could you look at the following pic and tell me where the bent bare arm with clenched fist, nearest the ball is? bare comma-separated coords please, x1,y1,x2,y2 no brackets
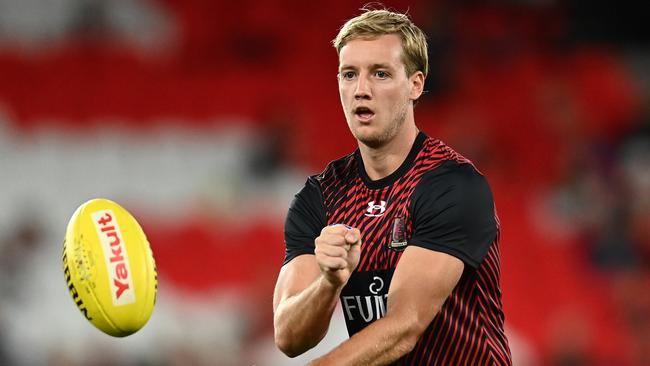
273,225,361,357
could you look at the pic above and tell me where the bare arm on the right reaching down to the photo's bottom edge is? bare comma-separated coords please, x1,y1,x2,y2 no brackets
310,246,464,365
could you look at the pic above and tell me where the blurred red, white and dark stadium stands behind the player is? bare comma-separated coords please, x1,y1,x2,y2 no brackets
0,0,650,365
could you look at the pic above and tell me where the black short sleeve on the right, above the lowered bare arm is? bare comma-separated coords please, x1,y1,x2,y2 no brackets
409,161,497,268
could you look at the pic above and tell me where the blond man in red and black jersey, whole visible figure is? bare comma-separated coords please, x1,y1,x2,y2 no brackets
273,10,511,365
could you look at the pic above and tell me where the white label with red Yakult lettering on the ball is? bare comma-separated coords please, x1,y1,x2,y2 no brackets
91,210,135,305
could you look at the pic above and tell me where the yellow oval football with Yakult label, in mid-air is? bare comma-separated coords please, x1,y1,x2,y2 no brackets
63,198,158,337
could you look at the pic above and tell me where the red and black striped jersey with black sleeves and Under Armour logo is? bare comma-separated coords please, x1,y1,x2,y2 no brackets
284,132,512,365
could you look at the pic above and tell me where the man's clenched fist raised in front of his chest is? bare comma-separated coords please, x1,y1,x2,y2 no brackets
315,225,361,288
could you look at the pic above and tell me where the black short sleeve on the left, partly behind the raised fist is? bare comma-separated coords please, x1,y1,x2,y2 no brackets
283,177,327,265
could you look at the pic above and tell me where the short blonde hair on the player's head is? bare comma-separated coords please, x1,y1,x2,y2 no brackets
332,8,429,78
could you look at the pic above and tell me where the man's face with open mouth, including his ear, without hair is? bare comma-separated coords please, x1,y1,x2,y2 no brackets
338,34,421,148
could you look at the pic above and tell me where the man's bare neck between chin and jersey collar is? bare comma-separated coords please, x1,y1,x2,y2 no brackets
359,124,418,180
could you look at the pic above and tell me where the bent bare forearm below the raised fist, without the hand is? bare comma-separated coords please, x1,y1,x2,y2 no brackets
274,277,341,357
